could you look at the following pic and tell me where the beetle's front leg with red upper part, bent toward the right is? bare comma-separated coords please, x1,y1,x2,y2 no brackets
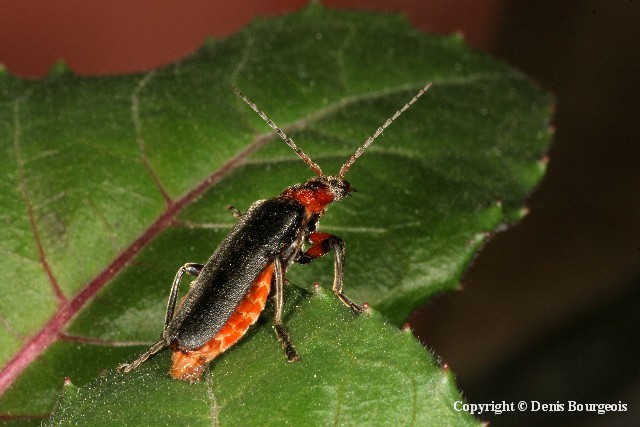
298,232,363,313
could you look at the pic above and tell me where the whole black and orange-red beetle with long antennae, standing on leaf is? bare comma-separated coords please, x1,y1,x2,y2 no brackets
118,83,431,382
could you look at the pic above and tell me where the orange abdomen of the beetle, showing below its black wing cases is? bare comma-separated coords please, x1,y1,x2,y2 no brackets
170,264,274,381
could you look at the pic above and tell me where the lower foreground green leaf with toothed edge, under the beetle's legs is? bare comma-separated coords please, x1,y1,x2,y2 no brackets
49,288,478,426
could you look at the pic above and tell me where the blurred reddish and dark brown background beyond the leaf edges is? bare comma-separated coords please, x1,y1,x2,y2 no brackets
0,0,640,426
